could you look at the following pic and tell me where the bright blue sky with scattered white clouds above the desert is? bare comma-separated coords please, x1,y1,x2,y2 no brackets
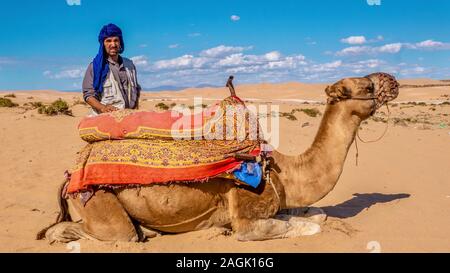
0,0,450,90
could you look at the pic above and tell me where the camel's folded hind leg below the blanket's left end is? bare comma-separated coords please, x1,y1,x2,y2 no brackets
46,190,139,242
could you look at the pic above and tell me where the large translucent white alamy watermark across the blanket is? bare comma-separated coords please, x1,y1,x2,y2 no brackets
171,97,280,149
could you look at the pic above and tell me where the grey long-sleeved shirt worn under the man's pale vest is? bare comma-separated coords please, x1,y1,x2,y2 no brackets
83,56,141,109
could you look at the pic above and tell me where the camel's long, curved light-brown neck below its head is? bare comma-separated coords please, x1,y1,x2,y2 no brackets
274,102,361,207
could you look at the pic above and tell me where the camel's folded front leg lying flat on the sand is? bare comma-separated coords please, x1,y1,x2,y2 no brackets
233,217,320,241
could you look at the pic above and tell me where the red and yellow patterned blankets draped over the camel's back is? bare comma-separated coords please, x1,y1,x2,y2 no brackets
68,97,261,193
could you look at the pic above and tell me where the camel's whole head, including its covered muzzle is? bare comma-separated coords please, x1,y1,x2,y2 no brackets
325,73,399,119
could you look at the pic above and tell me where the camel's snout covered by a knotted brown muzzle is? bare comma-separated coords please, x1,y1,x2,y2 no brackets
365,72,400,109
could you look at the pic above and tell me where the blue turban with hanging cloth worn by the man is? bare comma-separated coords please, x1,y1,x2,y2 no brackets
92,24,125,95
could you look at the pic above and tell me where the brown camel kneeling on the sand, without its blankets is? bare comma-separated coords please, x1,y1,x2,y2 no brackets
38,73,399,243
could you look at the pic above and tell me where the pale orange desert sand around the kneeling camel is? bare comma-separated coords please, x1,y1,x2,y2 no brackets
0,79,450,252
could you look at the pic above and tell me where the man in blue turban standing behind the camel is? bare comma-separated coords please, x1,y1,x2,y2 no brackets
83,24,141,115
